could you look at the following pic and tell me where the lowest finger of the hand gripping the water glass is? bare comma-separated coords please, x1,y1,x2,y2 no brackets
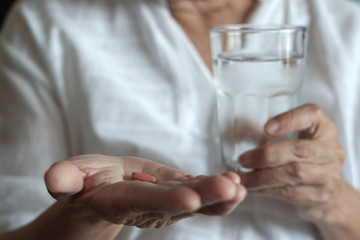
257,185,331,206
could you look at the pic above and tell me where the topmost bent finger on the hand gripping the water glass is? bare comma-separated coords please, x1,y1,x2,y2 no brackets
265,104,336,139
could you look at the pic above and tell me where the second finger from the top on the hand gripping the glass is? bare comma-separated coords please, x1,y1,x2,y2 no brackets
239,139,335,169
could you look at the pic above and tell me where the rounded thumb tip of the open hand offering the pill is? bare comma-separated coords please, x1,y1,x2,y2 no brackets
44,161,84,202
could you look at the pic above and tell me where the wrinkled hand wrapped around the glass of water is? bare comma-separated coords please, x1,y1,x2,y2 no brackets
239,104,345,221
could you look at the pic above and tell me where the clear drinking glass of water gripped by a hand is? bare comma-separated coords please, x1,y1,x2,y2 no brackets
210,24,306,172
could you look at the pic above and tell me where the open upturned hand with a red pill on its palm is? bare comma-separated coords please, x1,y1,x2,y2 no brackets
45,155,246,228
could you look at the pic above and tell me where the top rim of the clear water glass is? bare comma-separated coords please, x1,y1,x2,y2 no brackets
210,24,307,33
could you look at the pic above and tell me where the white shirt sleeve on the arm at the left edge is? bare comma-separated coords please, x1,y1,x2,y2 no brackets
0,1,68,232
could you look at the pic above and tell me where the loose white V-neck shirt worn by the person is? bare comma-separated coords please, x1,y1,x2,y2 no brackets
0,0,360,240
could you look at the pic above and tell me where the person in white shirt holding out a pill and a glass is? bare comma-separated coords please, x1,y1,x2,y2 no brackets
0,0,360,240
